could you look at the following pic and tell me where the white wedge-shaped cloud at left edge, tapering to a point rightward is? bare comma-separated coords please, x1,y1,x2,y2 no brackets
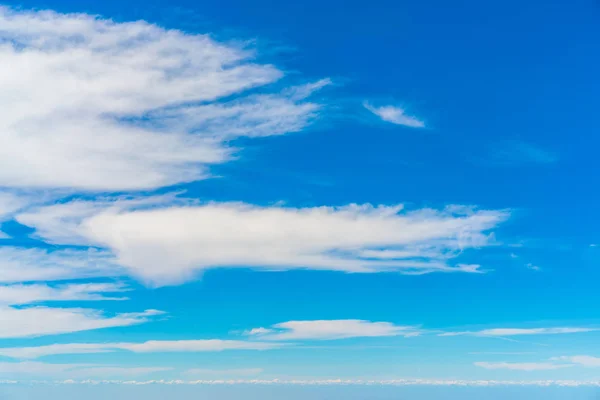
0,306,162,339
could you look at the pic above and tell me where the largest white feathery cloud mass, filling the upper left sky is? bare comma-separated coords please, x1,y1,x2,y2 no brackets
0,7,327,190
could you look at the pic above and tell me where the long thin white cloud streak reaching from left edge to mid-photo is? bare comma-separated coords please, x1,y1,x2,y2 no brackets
0,339,284,359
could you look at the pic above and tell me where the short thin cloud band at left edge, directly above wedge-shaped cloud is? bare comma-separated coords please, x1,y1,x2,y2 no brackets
0,283,127,305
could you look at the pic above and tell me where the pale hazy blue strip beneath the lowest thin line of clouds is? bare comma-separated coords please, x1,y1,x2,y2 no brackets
0,385,600,400
